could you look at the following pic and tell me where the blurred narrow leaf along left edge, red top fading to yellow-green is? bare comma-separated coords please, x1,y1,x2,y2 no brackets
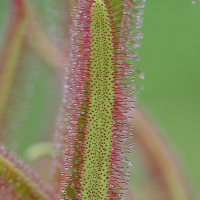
0,0,26,136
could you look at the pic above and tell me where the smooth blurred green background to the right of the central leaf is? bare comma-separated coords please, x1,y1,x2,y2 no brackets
139,0,200,192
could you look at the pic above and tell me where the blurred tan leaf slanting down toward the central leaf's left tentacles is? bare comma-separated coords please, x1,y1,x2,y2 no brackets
25,2,70,74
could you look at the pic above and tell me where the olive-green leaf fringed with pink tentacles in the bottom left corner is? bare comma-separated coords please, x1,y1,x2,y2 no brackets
0,145,57,200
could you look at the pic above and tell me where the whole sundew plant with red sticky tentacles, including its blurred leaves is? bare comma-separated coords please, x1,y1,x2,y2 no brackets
0,0,195,200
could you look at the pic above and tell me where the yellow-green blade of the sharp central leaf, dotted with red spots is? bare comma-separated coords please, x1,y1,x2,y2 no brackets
81,0,114,199
